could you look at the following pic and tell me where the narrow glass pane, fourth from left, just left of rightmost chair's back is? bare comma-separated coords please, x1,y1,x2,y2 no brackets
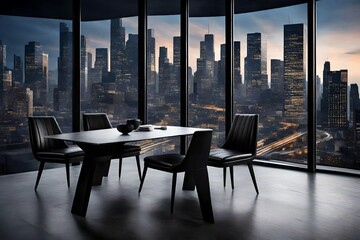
188,1,225,147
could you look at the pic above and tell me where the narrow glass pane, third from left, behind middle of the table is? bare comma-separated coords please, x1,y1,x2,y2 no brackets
147,0,180,153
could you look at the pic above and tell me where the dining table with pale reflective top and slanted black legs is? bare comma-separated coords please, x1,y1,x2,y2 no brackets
46,126,214,223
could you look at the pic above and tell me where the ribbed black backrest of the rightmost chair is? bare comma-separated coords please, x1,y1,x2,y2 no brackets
223,114,259,155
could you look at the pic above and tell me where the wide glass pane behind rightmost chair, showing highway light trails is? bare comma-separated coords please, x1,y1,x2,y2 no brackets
234,4,307,163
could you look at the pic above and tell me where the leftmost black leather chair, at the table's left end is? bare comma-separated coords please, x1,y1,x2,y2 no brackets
29,116,84,190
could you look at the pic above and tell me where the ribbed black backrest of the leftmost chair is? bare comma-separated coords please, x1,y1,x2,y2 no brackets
29,116,68,154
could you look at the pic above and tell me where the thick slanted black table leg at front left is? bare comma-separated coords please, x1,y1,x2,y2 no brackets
71,154,96,217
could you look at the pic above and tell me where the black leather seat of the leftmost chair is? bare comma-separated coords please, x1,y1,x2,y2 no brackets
36,146,84,162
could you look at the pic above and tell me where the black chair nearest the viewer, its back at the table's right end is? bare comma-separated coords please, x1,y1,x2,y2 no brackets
139,130,212,213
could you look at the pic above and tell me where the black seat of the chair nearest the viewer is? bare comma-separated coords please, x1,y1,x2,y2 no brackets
144,154,185,170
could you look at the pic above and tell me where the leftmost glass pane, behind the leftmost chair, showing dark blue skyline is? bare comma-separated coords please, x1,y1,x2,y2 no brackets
0,16,73,174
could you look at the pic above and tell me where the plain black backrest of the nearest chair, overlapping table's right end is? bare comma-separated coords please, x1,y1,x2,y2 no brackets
181,130,212,170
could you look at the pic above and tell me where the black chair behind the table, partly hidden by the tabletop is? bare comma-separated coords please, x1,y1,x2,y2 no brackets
83,113,141,179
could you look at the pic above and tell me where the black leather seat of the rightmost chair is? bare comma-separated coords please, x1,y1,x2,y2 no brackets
208,148,253,165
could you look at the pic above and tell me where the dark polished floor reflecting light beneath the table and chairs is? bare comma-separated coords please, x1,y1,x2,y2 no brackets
0,159,360,240
